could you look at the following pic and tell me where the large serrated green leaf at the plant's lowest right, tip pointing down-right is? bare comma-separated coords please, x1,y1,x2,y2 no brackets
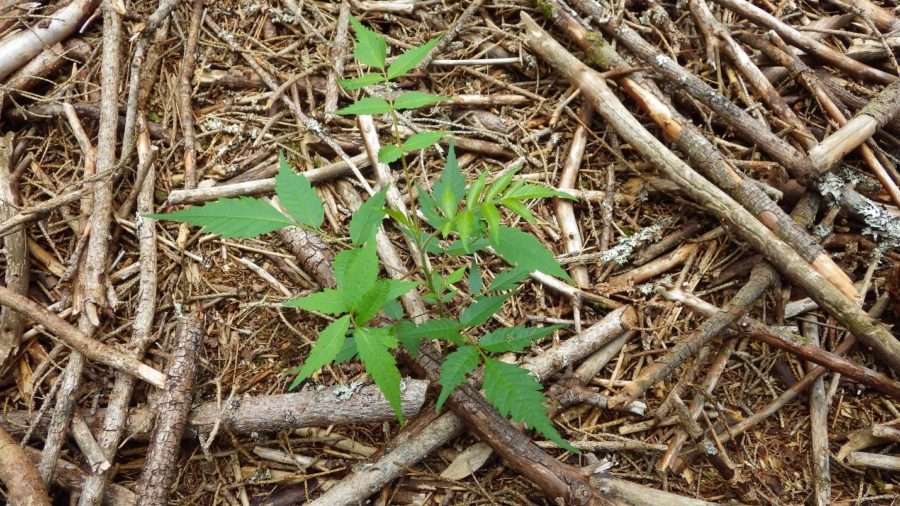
483,358,581,454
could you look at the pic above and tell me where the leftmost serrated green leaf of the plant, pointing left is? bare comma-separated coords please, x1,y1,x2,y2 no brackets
147,197,294,237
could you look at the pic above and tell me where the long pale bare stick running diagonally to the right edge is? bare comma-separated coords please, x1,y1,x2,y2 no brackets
523,15,900,371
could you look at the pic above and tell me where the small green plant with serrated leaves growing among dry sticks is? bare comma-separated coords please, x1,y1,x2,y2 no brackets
152,18,577,451
